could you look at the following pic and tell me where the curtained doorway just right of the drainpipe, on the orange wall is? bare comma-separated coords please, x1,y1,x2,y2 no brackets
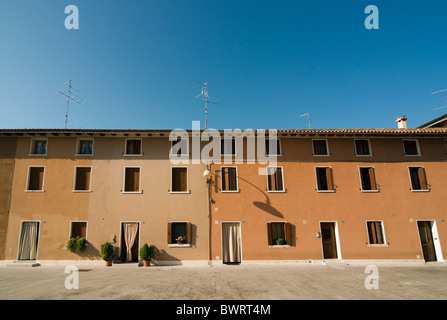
222,222,241,264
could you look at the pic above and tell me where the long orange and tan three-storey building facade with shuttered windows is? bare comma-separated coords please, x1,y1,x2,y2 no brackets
0,128,447,264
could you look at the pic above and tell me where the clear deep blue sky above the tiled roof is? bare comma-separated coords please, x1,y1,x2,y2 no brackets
0,0,447,129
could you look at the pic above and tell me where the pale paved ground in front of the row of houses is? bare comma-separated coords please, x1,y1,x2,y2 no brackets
0,263,447,300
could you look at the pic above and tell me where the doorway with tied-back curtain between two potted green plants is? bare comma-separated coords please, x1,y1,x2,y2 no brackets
120,222,140,262
